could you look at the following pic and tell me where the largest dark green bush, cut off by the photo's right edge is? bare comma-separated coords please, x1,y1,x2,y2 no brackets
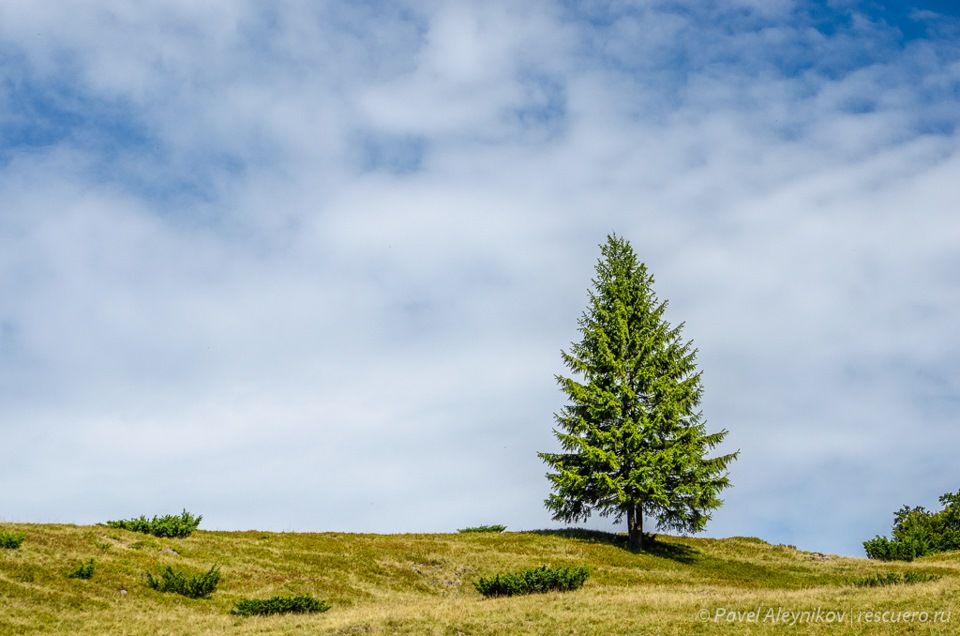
863,491,960,561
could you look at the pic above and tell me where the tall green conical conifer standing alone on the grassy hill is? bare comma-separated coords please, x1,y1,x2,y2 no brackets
539,234,739,548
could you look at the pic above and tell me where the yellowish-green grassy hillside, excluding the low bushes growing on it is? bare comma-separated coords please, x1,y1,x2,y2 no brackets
0,523,960,636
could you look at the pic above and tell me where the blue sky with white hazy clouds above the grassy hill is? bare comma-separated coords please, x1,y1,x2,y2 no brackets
0,0,960,556
